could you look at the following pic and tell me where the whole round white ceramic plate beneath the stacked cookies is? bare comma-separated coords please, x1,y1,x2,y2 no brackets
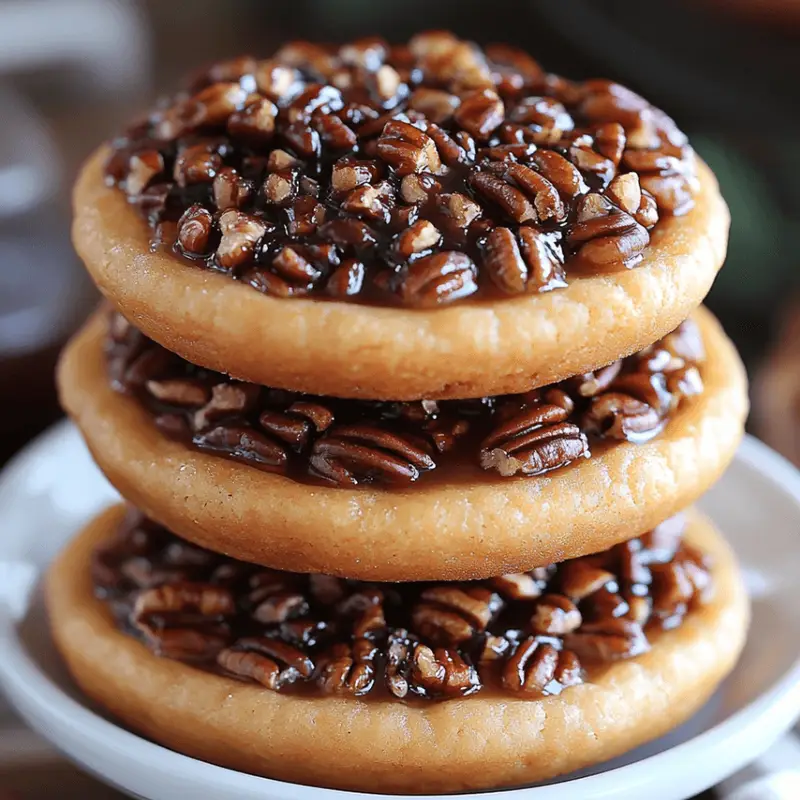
0,424,800,800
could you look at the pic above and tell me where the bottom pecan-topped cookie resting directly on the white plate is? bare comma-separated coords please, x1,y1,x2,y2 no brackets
47,507,748,793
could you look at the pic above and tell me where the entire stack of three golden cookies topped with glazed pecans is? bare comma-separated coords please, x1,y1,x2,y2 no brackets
48,32,748,792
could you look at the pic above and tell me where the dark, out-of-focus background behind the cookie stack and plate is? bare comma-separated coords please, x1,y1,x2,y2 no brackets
0,0,800,797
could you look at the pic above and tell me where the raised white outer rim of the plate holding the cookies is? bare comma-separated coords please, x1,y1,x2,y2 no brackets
0,420,800,800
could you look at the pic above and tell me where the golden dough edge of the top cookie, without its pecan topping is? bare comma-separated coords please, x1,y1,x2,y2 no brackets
73,149,729,400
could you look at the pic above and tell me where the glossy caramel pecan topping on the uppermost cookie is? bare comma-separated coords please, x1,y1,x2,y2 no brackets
106,32,695,307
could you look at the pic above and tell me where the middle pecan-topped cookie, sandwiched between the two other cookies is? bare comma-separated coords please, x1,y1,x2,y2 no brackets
59,310,747,581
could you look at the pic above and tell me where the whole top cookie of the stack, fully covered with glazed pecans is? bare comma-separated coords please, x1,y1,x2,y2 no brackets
75,33,727,399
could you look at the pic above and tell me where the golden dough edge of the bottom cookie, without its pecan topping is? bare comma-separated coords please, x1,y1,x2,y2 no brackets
47,507,749,793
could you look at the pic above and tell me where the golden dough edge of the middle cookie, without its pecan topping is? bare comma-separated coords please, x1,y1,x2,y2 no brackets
58,309,747,580
